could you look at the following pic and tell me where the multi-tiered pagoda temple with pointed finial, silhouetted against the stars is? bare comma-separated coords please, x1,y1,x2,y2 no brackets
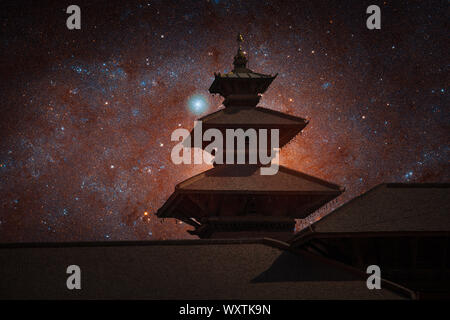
157,35,344,240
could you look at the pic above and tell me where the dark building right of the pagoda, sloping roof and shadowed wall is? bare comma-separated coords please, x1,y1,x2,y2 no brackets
291,183,450,298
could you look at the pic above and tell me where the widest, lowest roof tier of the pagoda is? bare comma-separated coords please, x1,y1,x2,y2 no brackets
157,165,343,222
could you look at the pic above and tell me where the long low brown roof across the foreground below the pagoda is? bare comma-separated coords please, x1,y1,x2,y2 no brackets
0,239,411,299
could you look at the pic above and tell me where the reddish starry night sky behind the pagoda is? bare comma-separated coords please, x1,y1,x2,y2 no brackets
0,0,450,242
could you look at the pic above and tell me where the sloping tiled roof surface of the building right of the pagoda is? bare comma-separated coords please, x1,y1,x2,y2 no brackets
296,183,450,233
